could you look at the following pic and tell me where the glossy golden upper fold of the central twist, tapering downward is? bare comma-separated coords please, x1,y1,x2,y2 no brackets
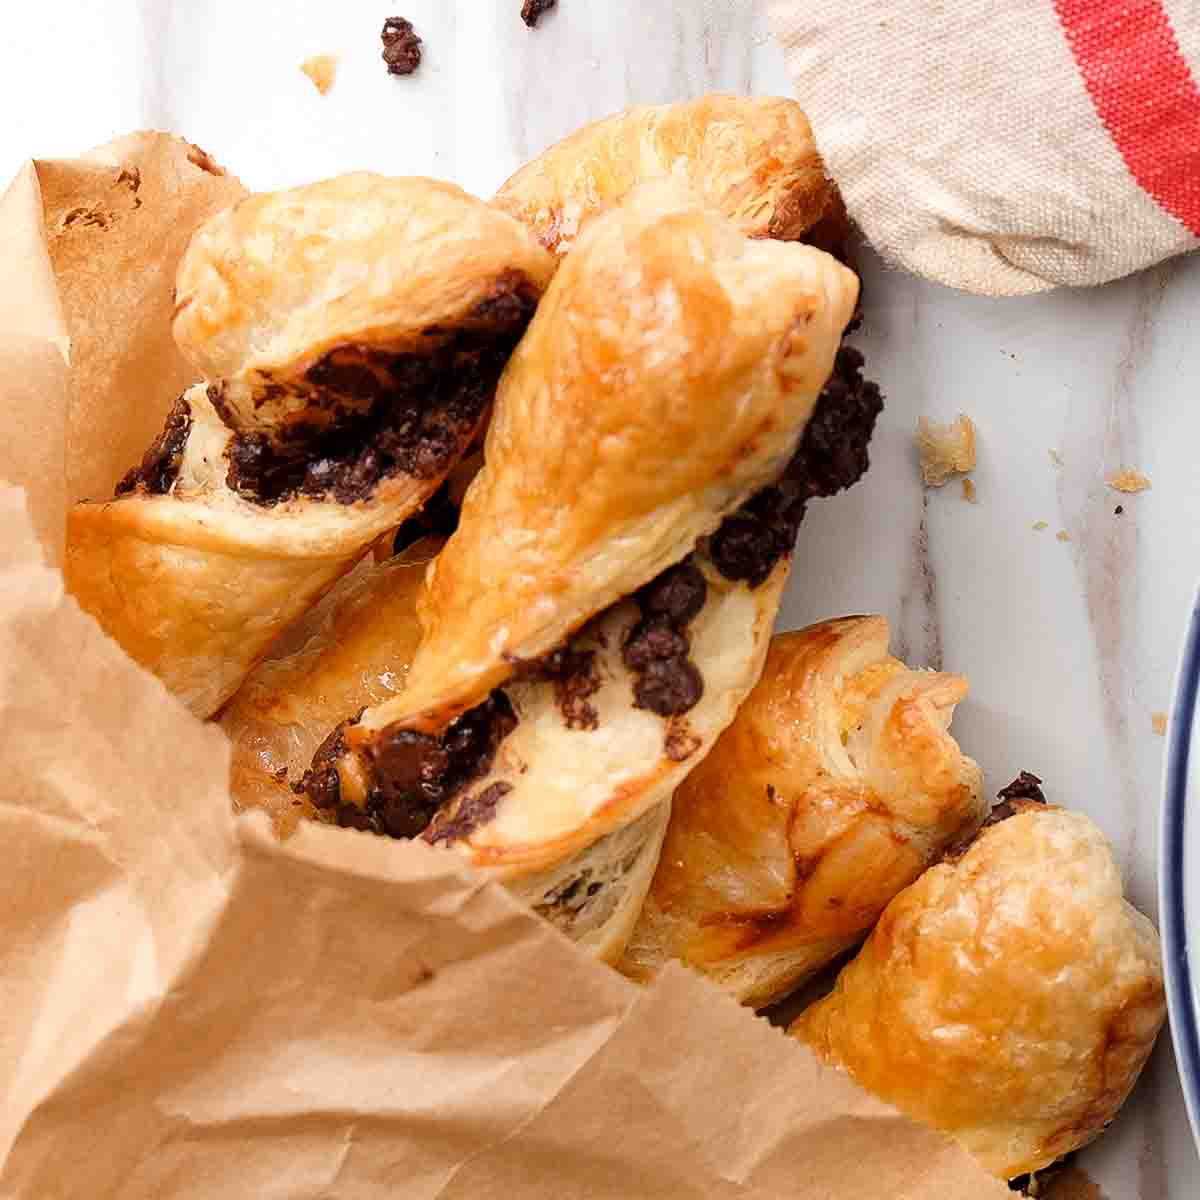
348,182,859,745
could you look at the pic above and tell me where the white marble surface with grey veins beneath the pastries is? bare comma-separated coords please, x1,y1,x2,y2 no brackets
0,0,1200,1200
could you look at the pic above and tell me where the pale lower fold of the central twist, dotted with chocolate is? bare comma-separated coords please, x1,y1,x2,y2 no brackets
304,553,788,962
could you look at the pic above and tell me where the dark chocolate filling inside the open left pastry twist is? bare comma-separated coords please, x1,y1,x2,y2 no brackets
222,272,538,504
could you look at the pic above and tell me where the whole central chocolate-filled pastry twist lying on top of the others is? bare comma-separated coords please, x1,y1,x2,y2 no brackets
292,182,880,954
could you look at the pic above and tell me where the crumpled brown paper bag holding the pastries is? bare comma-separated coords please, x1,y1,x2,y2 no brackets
0,134,1009,1200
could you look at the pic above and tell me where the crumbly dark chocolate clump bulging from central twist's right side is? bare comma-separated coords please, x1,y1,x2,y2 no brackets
708,346,883,588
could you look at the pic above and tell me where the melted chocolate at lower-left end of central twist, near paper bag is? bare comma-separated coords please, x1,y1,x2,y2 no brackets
298,691,517,840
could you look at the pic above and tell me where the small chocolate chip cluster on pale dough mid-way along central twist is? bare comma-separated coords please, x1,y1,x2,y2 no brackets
622,559,708,716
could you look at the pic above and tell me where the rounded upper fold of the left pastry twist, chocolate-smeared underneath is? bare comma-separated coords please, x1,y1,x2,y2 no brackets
174,172,553,442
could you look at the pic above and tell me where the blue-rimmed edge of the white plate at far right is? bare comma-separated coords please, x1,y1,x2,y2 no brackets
1158,594,1200,1145
